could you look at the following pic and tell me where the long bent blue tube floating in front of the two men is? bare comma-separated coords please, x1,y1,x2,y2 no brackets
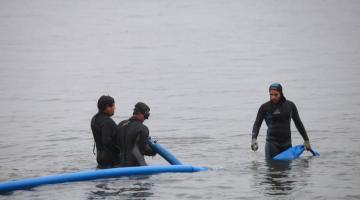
0,140,208,193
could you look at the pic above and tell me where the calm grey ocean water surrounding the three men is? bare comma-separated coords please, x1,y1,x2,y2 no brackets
0,0,360,199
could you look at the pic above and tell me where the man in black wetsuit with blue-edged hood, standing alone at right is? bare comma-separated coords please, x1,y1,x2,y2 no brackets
251,83,311,159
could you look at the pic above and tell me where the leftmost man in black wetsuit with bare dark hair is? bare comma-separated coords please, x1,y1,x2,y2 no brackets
91,96,120,169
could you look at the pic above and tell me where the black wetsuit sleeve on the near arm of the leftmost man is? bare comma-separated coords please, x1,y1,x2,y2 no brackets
101,121,120,153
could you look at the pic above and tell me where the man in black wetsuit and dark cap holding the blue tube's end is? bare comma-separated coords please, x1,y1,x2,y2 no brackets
117,102,156,167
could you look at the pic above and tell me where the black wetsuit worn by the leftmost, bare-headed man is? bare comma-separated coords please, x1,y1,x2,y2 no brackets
91,111,120,168
